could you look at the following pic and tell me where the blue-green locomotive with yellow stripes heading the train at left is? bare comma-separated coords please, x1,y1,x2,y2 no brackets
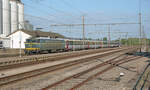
25,38,65,54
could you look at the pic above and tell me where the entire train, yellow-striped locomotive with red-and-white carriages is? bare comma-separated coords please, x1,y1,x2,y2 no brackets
25,37,119,54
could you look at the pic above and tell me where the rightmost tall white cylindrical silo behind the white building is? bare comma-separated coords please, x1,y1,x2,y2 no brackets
18,1,24,29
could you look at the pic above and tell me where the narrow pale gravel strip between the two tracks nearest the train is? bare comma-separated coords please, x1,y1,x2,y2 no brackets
0,50,122,78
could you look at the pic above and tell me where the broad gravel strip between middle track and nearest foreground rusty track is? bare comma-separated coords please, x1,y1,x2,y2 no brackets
2,50,124,90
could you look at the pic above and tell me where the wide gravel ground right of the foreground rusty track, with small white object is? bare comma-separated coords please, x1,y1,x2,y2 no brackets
78,57,149,90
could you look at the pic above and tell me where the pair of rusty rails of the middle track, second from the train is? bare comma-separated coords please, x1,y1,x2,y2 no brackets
0,49,131,86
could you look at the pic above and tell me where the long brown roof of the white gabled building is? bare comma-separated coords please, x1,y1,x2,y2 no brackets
7,30,65,38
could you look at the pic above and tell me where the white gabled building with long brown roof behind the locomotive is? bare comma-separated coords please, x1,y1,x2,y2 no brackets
7,30,65,49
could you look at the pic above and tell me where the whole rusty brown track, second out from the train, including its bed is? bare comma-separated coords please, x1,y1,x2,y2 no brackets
0,49,131,87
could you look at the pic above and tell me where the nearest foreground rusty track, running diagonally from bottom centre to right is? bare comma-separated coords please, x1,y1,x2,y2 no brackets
42,53,140,90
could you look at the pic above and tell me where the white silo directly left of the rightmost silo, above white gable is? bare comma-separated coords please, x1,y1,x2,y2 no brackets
10,0,19,33
